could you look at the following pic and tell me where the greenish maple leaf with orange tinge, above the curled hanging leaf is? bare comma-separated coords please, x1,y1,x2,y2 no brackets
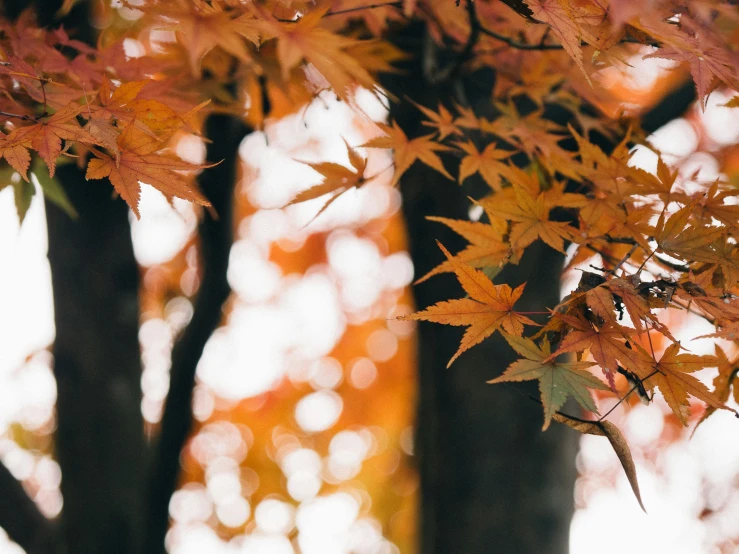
488,333,608,430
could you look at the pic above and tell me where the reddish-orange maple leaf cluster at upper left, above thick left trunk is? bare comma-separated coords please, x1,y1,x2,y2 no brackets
0,15,220,216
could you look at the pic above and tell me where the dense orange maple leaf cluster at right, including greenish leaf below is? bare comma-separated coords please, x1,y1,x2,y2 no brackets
398,112,739,428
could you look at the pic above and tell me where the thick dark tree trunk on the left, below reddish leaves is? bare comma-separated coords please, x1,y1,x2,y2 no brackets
47,165,145,554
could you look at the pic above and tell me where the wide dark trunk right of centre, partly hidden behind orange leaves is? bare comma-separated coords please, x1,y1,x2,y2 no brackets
382,26,577,554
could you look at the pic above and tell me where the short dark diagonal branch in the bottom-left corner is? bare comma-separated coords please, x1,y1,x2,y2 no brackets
0,463,58,554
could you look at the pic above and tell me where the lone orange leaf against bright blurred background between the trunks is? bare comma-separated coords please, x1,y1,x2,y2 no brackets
285,141,371,219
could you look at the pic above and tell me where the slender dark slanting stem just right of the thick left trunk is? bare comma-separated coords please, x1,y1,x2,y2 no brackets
144,115,250,554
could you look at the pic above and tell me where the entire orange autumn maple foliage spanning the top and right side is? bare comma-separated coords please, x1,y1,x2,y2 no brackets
0,0,739,508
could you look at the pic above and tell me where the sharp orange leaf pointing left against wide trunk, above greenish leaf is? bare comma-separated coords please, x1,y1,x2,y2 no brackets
399,241,536,367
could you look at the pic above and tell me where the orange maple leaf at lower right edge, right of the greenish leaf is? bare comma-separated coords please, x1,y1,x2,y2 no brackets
637,343,734,426
